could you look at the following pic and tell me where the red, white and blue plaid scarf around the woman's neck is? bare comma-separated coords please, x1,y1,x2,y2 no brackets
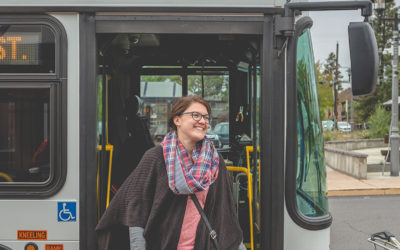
161,132,219,194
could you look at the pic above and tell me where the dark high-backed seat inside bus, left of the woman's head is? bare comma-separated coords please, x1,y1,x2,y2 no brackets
112,94,154,188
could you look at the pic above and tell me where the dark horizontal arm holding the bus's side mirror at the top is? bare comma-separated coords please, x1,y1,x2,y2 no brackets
285,1,372,21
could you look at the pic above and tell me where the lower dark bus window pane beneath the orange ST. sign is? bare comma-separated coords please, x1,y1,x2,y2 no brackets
0,88,51,183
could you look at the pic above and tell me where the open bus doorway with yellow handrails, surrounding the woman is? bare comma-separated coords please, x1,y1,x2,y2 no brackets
96,15,264,249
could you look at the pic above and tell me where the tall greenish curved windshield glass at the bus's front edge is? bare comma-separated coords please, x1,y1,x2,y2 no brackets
296,29,328,217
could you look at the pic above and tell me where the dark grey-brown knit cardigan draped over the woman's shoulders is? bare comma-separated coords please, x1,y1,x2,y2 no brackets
96,146,242,250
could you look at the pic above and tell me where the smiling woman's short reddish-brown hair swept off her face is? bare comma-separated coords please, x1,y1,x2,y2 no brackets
168,95,211,131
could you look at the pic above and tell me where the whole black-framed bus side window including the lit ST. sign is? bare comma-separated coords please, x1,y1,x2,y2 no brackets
0,15,68,198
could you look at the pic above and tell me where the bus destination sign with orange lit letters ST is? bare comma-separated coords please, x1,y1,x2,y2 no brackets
0,32,41,65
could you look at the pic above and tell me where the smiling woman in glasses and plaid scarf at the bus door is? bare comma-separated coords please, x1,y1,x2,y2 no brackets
96,96,245,250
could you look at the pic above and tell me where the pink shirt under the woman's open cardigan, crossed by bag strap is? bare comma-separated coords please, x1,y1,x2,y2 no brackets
178,190,208,250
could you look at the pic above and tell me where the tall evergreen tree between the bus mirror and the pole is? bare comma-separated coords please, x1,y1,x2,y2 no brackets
354,2,398,122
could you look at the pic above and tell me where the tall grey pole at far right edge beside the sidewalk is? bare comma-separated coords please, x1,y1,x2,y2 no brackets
390,13,400,176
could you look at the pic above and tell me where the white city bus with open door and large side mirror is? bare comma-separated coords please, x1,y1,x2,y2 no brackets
0,0,378,250
